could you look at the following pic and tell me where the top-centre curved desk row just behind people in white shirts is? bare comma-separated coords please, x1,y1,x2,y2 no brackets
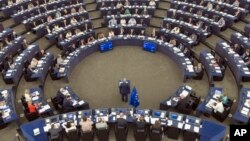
100,5,155,16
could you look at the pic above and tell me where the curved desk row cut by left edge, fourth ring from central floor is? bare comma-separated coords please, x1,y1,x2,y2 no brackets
0,36,24,64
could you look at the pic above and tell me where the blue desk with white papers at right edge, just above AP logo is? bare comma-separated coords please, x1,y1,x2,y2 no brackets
232,88,250,124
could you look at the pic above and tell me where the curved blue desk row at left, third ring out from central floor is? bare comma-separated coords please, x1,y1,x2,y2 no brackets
4,45,39,85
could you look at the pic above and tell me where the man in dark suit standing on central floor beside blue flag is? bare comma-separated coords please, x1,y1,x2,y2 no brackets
119,78,130,102
